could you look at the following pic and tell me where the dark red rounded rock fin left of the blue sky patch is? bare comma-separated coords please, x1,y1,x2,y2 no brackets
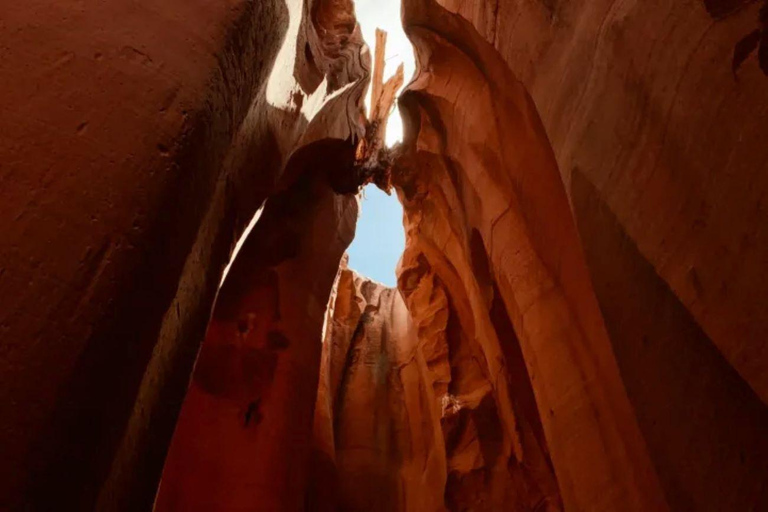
155,172,357,512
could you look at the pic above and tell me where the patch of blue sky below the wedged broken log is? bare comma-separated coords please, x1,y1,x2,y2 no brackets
347,185,405,286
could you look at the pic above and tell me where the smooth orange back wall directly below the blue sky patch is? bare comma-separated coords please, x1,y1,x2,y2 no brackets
309,268,446,512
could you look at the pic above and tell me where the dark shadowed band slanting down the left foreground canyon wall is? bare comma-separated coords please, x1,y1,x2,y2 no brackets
26,0,288,510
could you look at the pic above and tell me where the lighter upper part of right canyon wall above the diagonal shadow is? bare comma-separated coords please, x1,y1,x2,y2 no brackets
440,0,768,410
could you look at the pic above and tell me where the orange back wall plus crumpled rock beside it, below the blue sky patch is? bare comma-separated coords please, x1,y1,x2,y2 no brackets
308,260,562,512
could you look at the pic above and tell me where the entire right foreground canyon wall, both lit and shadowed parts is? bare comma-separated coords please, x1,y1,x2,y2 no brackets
428,0,768,510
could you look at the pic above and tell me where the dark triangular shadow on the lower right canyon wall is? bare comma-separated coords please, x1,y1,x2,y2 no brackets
571,168,768,511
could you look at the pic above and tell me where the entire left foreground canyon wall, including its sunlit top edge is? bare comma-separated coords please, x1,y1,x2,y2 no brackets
0,0,369,510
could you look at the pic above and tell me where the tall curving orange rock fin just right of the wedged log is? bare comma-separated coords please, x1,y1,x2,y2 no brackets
393,0,667,510
